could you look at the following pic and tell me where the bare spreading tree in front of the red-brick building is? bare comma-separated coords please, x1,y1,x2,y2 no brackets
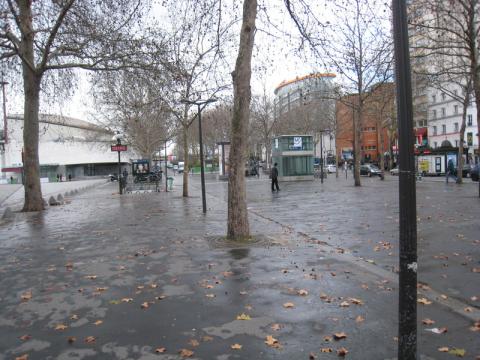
284,0,392,186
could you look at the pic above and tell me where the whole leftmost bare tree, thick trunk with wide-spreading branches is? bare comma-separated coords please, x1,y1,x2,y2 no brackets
0,0,154,211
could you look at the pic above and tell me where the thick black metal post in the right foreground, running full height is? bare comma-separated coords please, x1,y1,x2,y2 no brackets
392,0,417,360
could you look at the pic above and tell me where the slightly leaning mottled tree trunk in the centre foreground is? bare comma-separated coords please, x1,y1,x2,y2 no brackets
227,0,257,239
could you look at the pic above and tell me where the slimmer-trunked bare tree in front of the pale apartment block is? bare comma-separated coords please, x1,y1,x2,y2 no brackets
411,0,480,191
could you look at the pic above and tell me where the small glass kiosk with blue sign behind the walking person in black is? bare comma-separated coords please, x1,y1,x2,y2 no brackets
272,135,314,181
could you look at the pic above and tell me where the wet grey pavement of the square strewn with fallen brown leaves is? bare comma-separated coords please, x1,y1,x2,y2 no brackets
0,176,480,360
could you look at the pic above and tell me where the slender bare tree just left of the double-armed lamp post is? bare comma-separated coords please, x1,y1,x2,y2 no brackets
161,0,236,197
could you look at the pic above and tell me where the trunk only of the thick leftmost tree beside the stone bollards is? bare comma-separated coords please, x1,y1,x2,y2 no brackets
19,1,43,211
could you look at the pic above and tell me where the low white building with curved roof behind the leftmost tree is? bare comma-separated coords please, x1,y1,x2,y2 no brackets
1,115,135,182
